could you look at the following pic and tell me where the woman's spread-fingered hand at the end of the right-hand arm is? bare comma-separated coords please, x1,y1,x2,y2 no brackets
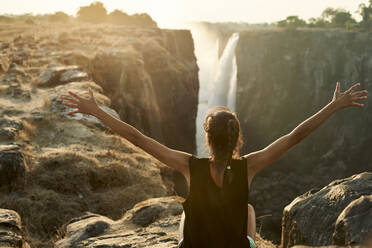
332,82,368,109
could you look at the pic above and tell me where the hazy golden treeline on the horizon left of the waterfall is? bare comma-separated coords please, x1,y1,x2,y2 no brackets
0,2,157,27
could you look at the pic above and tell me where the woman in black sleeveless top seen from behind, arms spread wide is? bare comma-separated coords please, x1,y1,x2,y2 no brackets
62,83,368,248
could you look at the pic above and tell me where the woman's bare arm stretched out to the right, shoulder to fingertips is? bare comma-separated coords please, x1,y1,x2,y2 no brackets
245,82,368,180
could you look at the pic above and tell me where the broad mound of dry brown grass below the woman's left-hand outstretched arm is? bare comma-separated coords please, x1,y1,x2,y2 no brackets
0,148,169,247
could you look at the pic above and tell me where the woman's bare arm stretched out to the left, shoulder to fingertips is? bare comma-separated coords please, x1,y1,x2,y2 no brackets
62,88,191,181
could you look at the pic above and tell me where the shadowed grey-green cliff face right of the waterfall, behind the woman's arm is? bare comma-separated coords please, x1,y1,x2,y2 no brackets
236,30,372,241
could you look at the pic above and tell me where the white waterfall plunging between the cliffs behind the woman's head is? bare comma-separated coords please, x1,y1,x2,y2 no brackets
191,27,239,157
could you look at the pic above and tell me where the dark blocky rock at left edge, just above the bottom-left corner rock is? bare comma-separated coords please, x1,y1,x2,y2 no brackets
0,145,27,191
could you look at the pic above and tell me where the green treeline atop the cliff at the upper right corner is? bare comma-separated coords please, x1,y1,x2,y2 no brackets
277,0,372,30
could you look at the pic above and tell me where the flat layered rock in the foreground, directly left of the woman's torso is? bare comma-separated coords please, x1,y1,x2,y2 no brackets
56,197,182,248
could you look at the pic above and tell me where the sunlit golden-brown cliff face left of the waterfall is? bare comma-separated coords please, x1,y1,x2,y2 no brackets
58,26,199,153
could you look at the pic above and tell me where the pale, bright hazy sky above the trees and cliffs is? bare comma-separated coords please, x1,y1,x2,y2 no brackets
0,0,368,27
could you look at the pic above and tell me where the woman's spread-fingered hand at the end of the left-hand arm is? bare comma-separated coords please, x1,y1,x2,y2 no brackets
62,88,99,115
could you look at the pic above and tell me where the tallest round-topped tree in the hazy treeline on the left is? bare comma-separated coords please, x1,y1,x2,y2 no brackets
77,2,107,23
